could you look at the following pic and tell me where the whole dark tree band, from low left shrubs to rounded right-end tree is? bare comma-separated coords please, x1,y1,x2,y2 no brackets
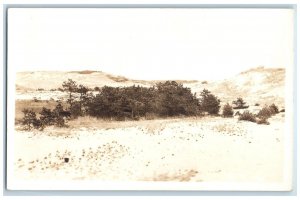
23,79,224,130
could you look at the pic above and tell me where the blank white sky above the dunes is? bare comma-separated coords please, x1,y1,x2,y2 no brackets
8,8,293,80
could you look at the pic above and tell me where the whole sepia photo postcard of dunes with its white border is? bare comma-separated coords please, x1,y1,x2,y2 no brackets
7,8,295,191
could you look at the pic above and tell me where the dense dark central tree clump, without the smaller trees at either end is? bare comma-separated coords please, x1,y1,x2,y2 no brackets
86,81,203,120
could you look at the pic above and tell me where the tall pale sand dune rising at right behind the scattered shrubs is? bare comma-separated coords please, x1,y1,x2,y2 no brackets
186,67,285,107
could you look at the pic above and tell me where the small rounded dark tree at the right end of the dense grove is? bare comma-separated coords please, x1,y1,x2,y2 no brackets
200,89,221,114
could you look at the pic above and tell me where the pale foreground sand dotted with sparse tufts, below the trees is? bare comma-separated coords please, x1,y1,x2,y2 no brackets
14,113,284,183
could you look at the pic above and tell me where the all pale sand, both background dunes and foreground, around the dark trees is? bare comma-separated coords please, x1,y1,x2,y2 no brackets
9,68,287,189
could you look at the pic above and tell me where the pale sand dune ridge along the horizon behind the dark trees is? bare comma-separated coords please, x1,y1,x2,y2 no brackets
16,67,285,107
